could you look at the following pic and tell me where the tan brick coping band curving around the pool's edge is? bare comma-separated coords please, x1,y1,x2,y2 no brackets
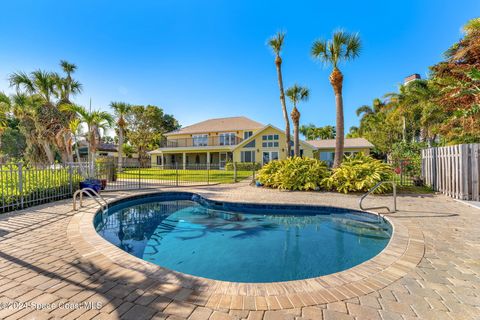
67,192,425,311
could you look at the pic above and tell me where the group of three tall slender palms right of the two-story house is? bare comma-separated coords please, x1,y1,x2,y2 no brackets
268,30,361,167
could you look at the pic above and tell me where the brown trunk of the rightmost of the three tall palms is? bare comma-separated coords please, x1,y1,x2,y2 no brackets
330,68,345,168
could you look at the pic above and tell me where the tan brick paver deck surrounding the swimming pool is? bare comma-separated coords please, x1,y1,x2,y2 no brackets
0,184,480,320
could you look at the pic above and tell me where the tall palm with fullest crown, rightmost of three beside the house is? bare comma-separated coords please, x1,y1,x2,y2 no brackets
311,30,361,168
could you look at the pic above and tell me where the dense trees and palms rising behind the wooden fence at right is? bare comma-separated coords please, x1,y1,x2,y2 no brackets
347,19,480,155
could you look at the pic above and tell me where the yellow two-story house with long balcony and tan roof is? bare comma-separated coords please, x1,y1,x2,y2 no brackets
150,117,376,168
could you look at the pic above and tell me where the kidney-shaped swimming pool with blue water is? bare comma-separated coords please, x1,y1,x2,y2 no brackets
94,192,392,282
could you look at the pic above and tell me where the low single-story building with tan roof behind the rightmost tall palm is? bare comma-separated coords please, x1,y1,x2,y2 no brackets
306,138,374,164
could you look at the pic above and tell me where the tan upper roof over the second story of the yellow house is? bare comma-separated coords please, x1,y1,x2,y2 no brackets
165,117,264,136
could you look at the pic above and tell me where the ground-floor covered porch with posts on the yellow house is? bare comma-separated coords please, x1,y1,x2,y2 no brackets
152,151,233,170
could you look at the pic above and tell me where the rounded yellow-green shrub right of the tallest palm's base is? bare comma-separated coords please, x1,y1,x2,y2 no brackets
323,153,393,193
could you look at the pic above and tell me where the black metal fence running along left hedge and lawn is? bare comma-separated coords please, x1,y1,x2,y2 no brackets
0,162,259,212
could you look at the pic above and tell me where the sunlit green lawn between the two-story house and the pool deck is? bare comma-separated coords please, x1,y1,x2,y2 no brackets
118,168,252,183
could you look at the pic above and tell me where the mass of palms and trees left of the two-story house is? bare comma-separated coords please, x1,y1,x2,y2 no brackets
0,61,178,166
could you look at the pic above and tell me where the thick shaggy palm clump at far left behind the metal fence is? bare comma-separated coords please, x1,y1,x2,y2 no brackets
2,61,82,163
